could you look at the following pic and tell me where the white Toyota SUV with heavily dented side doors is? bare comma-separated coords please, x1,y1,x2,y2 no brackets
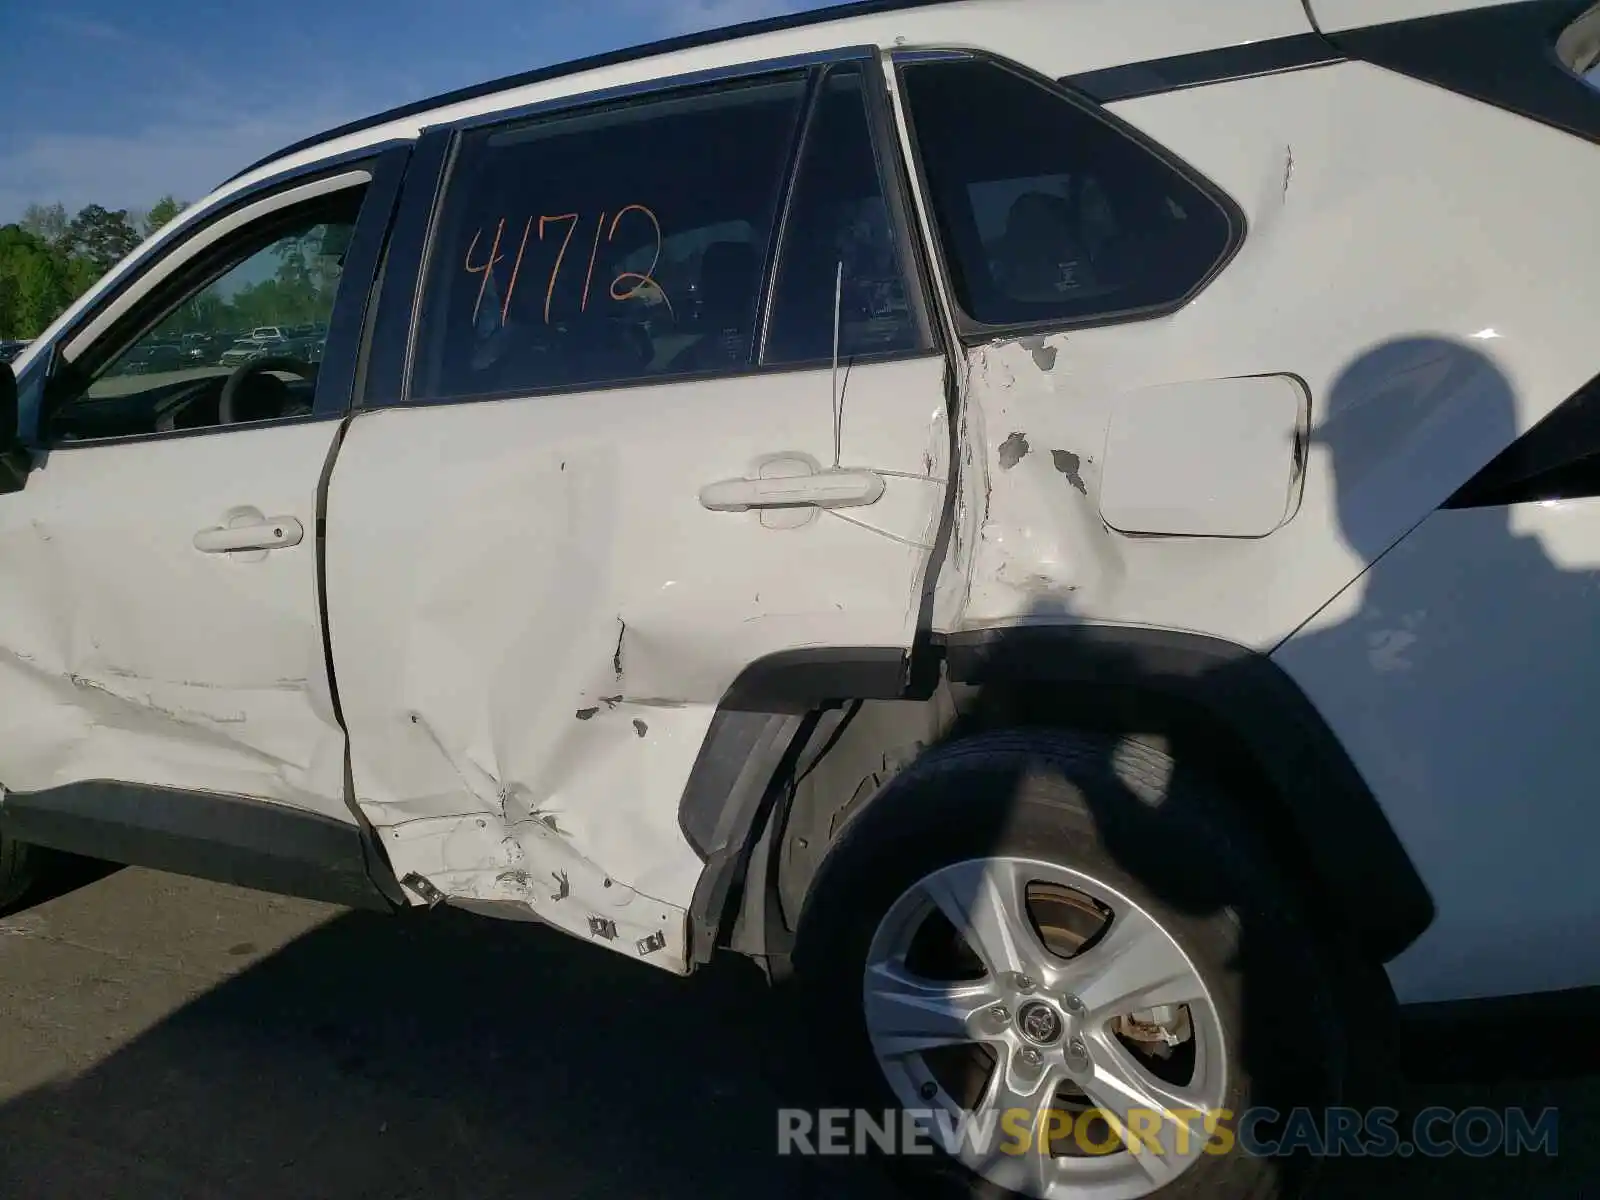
0,0,1600,1198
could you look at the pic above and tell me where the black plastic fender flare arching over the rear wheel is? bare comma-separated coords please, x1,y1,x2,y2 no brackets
678,626,1435,962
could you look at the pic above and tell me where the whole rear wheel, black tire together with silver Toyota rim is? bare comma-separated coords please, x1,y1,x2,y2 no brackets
794,731,1350,1200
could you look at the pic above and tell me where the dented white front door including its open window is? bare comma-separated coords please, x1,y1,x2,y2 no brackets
0,168,387,838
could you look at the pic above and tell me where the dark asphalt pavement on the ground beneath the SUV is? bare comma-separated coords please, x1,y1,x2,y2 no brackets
0,867,1600,1200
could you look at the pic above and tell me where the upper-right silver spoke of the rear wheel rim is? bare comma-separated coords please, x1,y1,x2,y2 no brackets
1062,906,1206,1024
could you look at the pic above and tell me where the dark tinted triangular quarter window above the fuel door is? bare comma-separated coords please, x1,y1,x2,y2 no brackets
901,58,1238,334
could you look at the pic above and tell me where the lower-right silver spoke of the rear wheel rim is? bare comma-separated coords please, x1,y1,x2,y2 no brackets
1077,1032,1210,1184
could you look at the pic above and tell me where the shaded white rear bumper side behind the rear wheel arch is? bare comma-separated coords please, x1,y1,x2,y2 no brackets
1277,499,1600,1002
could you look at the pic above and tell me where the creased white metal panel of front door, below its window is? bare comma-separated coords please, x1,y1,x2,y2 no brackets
0,421,354,822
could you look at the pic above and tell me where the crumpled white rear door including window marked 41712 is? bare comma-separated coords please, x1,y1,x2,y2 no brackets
328,56,949,971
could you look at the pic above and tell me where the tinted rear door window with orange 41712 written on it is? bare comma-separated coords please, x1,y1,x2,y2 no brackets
411,72,806,400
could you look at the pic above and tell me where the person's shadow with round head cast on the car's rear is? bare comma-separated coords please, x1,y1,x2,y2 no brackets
1275,338,1600,1080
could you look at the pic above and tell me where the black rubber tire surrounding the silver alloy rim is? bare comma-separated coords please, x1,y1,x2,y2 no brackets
795,733,1342,1200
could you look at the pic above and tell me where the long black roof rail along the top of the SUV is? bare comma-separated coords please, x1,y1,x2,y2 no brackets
219,0,947,186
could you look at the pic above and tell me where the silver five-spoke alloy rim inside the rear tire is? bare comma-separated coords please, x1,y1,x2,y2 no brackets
861,858,1229,1200
